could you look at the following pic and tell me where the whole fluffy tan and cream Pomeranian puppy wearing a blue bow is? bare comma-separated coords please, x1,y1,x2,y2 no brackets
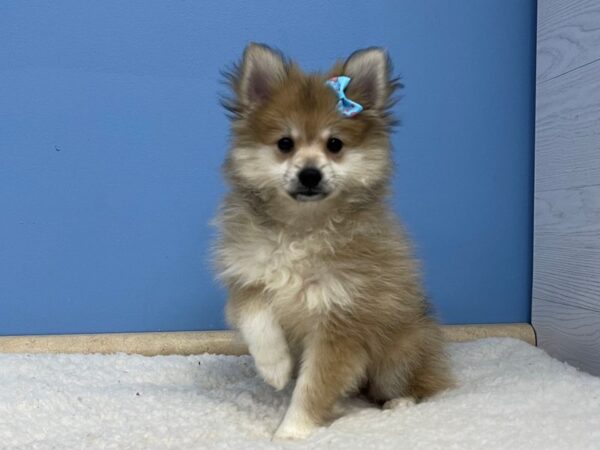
215,44,451,439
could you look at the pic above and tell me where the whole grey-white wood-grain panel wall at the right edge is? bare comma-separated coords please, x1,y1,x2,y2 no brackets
532,0,600,375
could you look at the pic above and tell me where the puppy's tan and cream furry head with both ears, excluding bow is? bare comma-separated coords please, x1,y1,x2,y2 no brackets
224,44,398,213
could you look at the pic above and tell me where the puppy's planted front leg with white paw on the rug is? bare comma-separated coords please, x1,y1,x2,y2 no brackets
275,334,367,439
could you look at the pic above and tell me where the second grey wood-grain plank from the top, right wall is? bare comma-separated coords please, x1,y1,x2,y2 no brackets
535,58,600,192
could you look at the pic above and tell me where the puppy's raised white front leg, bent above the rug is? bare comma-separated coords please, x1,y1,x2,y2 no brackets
228,290,293,390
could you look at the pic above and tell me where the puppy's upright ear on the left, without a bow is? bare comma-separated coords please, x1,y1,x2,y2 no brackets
235,43,287,108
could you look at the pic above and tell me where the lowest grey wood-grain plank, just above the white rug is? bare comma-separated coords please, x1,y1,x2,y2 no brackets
533,300,600,375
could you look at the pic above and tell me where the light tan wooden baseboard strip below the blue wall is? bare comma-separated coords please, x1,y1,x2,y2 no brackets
0,323,535,356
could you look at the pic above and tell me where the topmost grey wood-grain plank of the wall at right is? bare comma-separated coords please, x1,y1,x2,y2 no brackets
537,0,600,83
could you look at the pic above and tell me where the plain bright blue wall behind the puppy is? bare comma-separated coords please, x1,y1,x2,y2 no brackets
0,0,535,334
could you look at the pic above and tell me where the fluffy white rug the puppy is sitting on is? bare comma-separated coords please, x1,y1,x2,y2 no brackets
0,339,600,450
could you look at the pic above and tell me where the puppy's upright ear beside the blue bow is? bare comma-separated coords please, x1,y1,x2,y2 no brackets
343,47,395,110
